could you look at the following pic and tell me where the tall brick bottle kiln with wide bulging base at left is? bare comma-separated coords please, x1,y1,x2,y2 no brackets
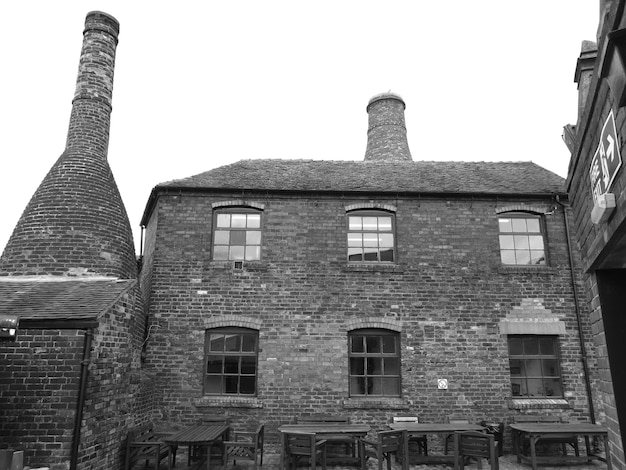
0,11,137,279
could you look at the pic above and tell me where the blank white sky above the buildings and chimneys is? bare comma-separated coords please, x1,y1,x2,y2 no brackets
0,0,599,255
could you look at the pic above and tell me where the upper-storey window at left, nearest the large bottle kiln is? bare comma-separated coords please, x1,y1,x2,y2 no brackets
213,208,261,261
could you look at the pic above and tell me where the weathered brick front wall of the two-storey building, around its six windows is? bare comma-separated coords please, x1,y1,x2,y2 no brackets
146,194,591,452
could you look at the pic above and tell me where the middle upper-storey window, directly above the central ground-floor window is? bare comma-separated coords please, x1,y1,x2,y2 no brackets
348,211,396,262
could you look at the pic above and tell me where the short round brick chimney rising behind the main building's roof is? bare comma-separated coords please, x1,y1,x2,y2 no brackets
365,93,413,162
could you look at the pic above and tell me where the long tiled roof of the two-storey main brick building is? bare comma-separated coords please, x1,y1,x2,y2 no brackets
156,159,565,195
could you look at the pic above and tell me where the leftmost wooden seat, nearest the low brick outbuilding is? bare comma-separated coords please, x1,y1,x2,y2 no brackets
125,423,171,470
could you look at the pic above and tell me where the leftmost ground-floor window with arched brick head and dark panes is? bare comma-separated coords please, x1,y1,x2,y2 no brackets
204,328,259,395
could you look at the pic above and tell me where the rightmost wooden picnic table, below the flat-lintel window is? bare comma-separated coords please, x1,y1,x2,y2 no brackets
510,422,613,470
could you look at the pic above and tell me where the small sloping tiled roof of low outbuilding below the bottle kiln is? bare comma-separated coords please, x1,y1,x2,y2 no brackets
0,276,136,320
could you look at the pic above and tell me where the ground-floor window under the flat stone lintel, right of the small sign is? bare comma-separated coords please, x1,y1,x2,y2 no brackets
508,335,563,398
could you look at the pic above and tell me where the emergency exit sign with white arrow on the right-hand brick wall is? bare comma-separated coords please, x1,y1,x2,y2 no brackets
589,110,622,205
